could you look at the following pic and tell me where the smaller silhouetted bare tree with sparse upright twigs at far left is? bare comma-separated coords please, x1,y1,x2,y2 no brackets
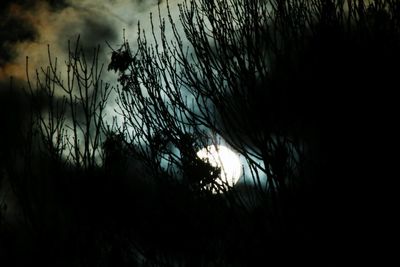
1,38,120,265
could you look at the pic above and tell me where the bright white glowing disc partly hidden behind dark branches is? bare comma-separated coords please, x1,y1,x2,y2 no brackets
197,145,242,189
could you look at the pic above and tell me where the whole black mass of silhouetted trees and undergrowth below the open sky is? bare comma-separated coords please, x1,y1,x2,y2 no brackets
0,0,400,266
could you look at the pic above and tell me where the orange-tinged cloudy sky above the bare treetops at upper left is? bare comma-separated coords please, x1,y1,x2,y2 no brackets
0,0,181,84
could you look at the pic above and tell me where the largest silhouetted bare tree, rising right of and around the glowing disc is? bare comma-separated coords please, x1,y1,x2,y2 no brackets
109,0,400,264
